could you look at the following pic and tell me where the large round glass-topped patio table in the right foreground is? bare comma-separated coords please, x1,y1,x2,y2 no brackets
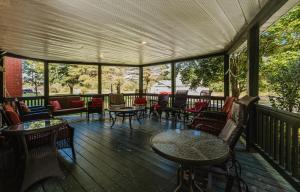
150,129,230,191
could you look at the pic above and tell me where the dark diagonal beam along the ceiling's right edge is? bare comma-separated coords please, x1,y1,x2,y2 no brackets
225,0,288,54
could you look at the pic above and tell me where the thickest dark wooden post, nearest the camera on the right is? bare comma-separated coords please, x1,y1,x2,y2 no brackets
246,25,259,150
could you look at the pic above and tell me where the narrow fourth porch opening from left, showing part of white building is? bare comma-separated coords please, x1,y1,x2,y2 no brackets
143,64,172,93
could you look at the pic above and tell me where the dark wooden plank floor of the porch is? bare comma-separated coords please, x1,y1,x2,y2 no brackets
28,116,296,192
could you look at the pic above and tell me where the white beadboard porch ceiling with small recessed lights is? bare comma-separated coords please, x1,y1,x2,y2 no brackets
0,0,296,65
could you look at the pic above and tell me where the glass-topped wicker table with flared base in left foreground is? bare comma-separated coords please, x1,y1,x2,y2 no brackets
2,118,67,191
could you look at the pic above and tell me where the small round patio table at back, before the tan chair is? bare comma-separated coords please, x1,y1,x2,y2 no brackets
108,106,146,129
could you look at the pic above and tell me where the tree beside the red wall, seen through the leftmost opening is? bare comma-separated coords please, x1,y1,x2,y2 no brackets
23,60,44,96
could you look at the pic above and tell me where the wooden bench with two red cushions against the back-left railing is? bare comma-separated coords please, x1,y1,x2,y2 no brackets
48,96,87,116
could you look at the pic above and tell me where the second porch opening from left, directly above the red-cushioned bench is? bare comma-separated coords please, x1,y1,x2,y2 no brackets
49,63,98,95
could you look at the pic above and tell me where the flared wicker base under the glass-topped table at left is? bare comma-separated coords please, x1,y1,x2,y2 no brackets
20,124,63,191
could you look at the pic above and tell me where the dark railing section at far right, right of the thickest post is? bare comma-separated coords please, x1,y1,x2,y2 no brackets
253,104,300,189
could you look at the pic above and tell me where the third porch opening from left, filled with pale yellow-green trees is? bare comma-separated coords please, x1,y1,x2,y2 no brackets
102,66,139,94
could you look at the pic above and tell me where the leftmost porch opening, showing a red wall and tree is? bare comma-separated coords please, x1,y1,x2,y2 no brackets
4,57,44,97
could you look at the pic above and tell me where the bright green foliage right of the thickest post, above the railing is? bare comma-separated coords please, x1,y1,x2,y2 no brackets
260,5,300,111
